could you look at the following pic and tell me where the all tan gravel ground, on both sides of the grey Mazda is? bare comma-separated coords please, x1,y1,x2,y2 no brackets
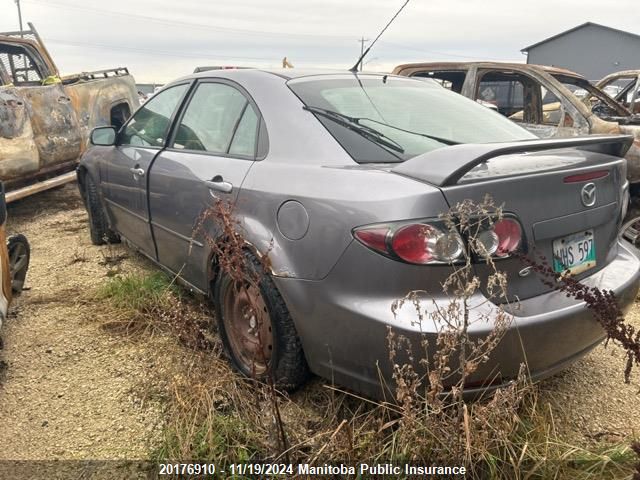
0,185,640,459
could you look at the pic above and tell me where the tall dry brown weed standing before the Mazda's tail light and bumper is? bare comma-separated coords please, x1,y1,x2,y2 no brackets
387,196,525,468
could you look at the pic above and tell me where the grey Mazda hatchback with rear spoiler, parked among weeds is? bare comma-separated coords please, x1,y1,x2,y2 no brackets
78,69,640,397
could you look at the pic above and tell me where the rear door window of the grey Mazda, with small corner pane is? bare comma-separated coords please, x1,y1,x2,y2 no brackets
173,83,258,157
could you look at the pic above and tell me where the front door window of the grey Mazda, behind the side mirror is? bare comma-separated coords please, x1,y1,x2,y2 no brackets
118,83,189,147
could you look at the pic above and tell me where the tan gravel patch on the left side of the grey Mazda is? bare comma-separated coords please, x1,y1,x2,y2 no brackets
0,185,178,459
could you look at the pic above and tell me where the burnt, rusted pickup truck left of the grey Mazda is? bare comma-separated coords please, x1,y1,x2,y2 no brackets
0,24,139,202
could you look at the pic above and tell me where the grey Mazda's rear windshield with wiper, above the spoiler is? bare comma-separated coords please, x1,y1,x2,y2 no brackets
288,75,536,163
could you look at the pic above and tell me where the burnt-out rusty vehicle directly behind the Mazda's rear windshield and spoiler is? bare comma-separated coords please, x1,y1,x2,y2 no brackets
393,62,640,184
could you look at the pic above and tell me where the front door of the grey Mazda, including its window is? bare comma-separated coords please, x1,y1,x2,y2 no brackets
101,83,189,258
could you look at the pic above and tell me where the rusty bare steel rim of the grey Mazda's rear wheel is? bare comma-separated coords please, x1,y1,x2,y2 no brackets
223,281,273,376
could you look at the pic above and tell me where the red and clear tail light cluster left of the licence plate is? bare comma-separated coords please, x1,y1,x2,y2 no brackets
353,218,522,265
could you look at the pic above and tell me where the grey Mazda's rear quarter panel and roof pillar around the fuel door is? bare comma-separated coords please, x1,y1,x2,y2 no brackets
228,71,447,280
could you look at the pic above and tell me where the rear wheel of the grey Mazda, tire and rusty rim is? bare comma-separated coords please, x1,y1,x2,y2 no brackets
214,254,309,391
